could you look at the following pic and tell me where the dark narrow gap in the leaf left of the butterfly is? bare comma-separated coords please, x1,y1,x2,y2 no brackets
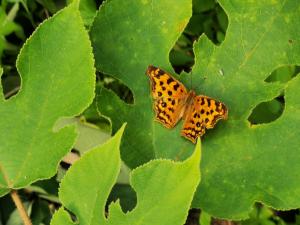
97,73,134,104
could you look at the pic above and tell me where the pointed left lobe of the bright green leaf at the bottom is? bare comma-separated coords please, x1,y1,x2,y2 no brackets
51,125,125,224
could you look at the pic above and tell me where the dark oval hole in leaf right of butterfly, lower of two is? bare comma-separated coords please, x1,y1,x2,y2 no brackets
248,96,285,124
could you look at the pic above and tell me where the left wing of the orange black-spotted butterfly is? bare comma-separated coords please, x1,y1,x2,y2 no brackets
146,66,188,128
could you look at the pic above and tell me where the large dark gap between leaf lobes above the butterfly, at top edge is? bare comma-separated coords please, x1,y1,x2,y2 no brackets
169,0,228,74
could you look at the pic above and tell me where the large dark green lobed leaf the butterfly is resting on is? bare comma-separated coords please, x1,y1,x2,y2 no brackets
91,0,300,219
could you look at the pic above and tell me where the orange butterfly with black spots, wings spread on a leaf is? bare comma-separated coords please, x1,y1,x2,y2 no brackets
146,65,228,143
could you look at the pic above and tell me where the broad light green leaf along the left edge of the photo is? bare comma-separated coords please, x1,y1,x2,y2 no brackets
0,5,95,196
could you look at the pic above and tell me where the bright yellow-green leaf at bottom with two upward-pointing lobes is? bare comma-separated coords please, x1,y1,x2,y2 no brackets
51,126,201,225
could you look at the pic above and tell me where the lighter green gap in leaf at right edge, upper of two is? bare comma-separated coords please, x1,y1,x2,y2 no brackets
265,65,300,83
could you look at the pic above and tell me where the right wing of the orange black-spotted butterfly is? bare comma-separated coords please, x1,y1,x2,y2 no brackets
181,95,228,143
